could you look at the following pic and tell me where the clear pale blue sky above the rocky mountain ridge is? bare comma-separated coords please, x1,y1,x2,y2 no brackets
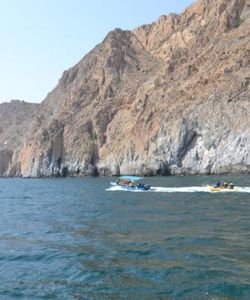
0,0,195,102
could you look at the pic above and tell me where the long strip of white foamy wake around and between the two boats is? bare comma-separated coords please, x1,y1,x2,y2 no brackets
106,186,250,193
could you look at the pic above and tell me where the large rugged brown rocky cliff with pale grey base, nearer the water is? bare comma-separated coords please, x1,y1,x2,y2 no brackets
1,0,250,176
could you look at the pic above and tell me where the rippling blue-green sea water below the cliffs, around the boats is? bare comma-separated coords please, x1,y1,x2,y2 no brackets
0,176,250,300
